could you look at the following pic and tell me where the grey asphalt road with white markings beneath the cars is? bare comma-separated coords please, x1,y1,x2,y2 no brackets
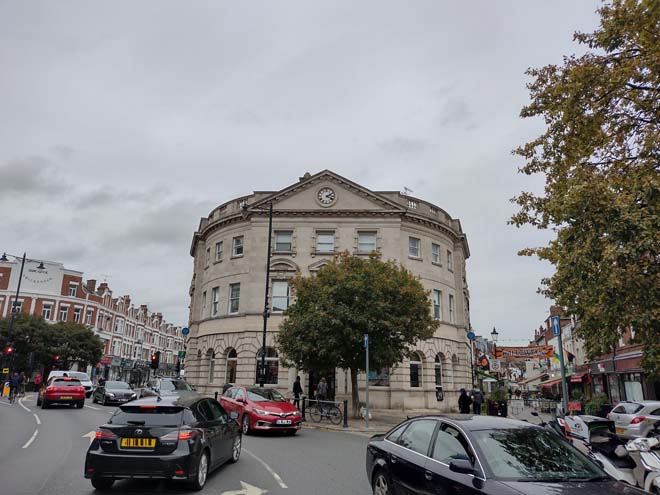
0,394,371,495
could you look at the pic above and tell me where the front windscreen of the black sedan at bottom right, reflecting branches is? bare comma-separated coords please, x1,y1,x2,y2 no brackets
473,428,605,481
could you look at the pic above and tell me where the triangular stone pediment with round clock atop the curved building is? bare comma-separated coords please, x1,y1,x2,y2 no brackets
255,170,406,211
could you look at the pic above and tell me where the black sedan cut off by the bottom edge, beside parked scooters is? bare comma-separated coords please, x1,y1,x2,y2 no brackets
367,415,645,495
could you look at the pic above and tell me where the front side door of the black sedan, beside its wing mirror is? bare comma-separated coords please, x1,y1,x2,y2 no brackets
423,422,483,495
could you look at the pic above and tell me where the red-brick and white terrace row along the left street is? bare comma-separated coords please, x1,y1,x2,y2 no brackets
0,261,184,383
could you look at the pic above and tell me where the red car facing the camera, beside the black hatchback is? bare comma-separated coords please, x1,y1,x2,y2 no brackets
220,387,302,435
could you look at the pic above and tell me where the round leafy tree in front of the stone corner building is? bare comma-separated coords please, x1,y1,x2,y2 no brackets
277,253,438,417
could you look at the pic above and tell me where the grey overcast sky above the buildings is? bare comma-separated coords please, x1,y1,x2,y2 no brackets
0,0,599,344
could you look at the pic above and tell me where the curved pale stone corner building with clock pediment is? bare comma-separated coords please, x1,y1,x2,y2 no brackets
186,170,471,411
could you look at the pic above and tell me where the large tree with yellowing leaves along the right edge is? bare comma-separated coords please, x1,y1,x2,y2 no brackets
511,0,660,377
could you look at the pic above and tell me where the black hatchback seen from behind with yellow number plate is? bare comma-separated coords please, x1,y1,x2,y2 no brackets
85,394,241,490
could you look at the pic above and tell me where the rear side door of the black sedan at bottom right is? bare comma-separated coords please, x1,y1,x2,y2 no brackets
388,419,439,495
